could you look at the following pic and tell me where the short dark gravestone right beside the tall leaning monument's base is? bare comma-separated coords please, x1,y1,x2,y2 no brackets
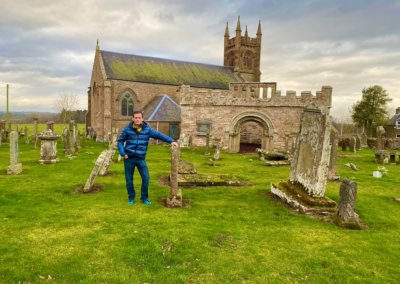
337,179,360,228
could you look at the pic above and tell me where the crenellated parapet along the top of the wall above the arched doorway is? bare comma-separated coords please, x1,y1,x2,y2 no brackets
180,82,332,108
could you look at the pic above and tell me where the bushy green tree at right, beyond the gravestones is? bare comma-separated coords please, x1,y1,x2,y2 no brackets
351,85,392,136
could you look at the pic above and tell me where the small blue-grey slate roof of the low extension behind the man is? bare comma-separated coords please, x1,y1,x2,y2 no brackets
143,95,181,122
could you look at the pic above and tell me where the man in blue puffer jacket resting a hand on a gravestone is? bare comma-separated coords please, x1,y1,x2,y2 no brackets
118,111,178,205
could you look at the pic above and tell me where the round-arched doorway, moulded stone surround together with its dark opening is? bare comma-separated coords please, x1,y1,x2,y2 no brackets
229,111,274,153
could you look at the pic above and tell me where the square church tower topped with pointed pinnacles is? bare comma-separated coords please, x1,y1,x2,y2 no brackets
224,16,262,82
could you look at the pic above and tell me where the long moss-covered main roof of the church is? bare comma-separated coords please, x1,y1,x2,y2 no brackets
100,50,243,89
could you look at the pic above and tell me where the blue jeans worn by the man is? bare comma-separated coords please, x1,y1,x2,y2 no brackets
124,157,150,201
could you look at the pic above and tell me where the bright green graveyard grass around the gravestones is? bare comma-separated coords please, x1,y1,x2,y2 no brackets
0,135,400,283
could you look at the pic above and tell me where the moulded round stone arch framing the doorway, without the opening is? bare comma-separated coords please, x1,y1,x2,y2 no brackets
229,111,274,153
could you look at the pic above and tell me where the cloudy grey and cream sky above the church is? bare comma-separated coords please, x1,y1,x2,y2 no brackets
0,0,400,120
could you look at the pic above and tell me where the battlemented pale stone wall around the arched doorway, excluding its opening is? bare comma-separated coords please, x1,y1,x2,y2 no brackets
179,83,332,152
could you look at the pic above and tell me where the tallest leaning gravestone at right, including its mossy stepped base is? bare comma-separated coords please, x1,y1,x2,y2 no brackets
271,105,336,213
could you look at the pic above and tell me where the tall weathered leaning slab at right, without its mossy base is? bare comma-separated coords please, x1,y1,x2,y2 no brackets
289,105,331,197
